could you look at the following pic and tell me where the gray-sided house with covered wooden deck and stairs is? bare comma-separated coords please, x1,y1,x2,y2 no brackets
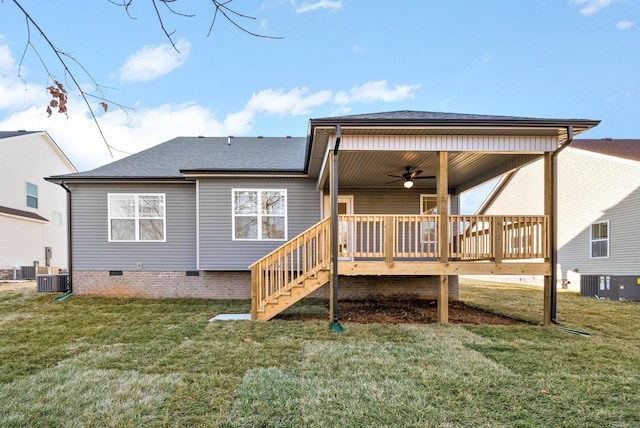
48,111,598,322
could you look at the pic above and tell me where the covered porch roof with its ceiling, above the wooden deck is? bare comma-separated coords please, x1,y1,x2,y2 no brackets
307,110,599,193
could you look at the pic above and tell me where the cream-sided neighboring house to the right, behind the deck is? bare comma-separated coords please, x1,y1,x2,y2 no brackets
478,138,640,300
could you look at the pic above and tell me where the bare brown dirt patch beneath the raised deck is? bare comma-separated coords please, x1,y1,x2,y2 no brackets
277,300,527,325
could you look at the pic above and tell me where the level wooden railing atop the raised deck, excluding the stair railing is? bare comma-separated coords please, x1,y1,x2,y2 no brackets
338,214,549,262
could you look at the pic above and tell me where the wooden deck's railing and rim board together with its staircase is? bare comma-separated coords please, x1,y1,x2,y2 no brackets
250,214,551,320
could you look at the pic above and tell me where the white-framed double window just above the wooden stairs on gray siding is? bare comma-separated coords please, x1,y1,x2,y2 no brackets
233,189,287,240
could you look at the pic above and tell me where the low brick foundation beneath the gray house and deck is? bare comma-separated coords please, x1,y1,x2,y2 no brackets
72,270,459,300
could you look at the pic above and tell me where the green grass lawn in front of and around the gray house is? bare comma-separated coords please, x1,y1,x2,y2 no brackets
0,281,640,427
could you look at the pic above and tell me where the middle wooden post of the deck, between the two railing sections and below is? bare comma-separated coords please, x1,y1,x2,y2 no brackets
436,152,449,324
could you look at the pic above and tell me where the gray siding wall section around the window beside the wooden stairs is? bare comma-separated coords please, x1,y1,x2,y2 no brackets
200,178,320,270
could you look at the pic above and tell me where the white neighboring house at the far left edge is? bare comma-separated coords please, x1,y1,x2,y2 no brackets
0,131,76,280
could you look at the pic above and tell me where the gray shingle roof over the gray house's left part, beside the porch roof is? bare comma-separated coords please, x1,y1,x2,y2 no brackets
55,137,306,179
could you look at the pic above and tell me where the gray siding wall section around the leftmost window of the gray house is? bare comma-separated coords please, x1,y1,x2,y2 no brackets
70,183,196,271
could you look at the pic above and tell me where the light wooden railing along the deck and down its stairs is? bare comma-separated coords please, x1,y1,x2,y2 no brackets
250,214,549,315
